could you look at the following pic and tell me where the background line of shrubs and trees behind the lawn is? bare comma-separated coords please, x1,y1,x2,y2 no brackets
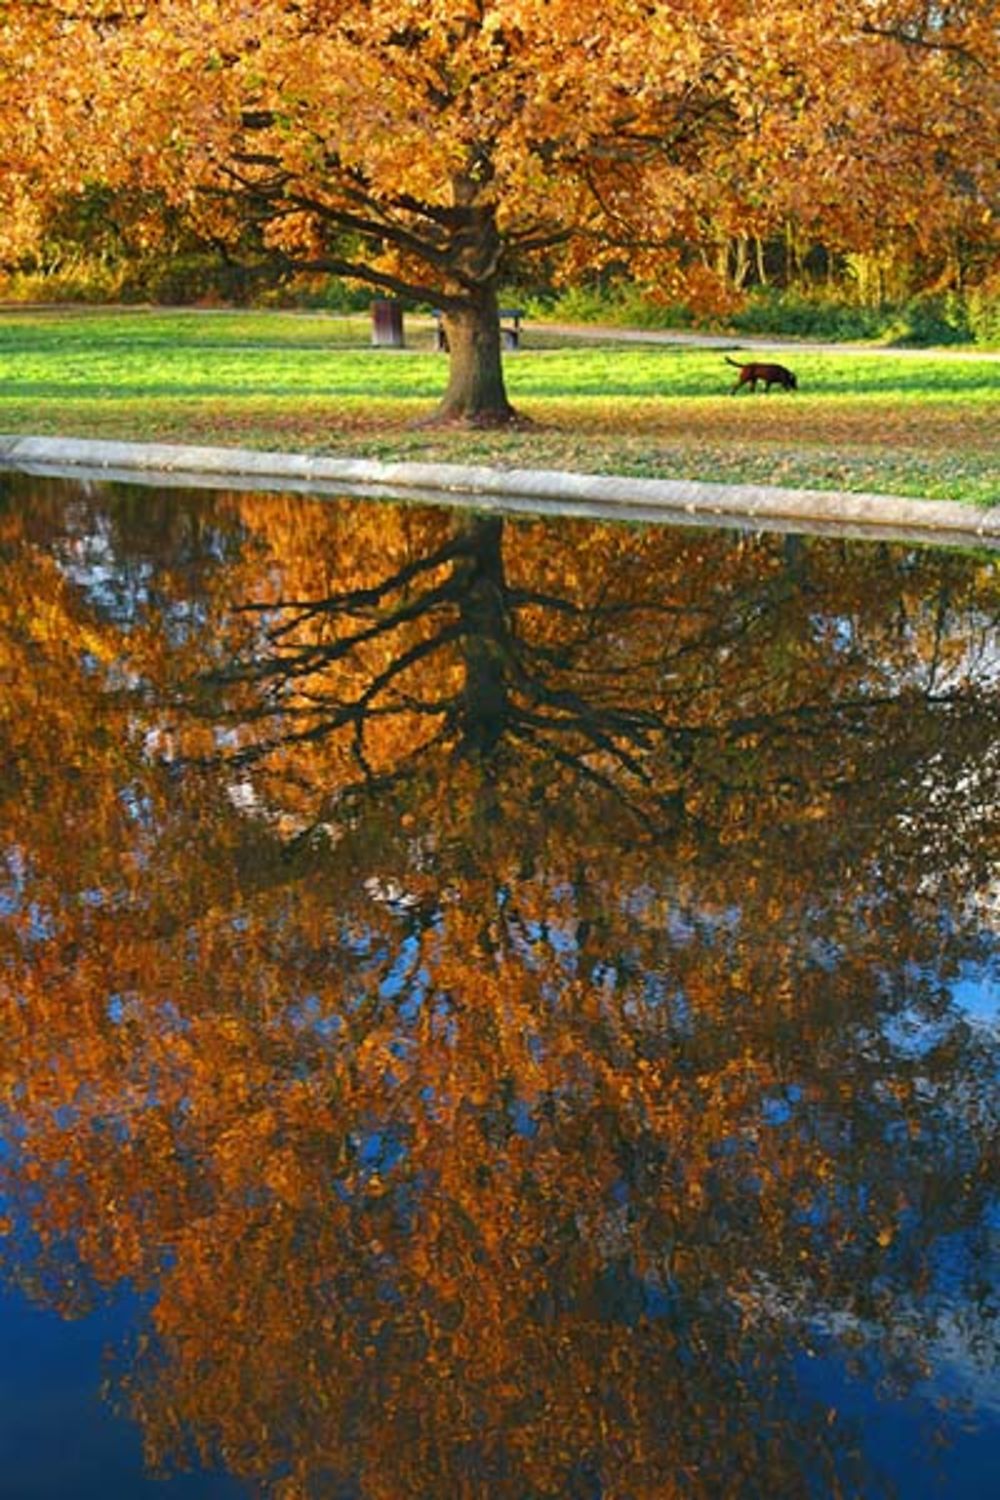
7,185,1000,344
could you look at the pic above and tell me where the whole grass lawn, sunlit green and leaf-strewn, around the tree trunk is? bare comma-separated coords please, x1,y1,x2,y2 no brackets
0,308,1000,504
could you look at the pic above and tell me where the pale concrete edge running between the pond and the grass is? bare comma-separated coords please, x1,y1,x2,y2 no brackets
0,435,1000,546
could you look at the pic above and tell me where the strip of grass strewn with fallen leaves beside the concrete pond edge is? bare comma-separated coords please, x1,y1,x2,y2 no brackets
0,396,1000,504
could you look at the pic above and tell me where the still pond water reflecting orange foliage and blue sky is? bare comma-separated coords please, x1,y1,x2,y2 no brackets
0,476,1000,1500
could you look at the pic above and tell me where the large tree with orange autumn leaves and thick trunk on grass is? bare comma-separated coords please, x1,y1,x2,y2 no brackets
0,0,997,423
